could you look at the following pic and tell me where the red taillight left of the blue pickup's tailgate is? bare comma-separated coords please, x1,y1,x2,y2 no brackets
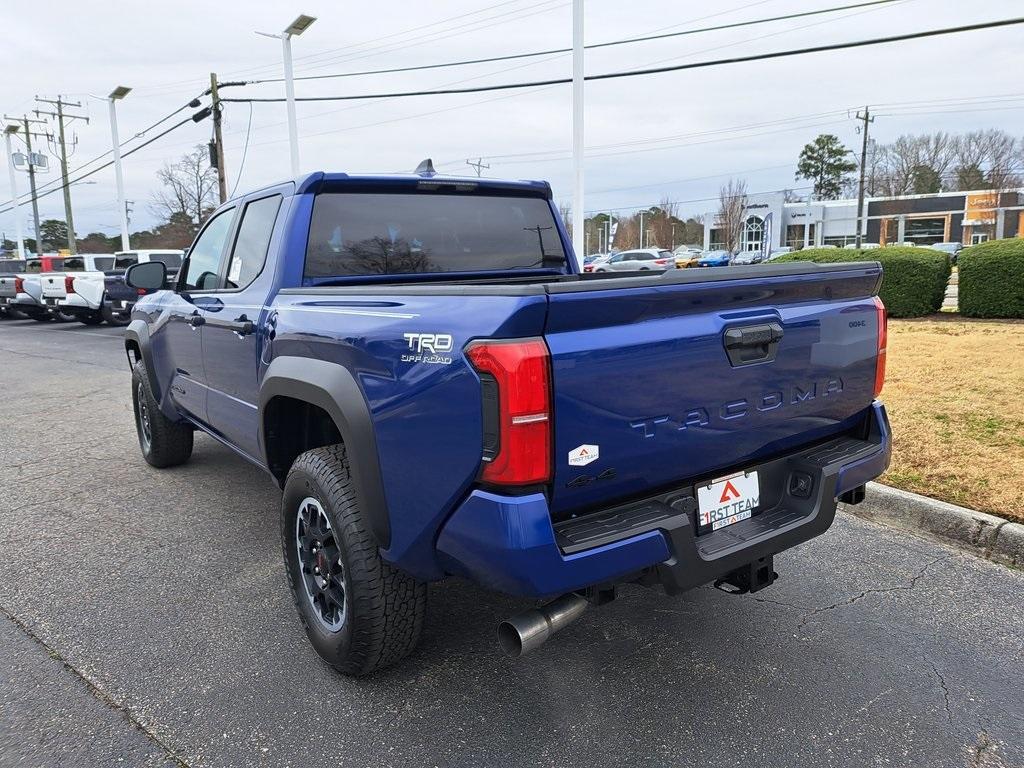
466,339,551,485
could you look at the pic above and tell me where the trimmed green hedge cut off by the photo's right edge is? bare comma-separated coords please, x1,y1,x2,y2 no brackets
956,238,1024,317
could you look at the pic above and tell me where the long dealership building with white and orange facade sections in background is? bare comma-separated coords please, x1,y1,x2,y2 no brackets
703,189,1024,251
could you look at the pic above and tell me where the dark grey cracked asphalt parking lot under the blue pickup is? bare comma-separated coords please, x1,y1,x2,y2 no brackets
0,321,1024,767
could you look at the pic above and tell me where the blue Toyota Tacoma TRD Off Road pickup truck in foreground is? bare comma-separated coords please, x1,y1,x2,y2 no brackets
117,166,891,675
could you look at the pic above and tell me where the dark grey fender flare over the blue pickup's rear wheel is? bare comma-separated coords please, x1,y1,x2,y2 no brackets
259,356,391,549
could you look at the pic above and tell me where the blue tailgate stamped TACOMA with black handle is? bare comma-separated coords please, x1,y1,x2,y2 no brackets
545,263,881,516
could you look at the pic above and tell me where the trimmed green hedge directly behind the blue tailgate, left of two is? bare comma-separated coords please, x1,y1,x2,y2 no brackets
775,246,950,317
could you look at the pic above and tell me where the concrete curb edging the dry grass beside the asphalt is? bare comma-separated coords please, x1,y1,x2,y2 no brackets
841,482,1024,568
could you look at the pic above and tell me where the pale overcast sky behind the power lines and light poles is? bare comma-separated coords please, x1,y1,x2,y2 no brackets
0,0,1024,238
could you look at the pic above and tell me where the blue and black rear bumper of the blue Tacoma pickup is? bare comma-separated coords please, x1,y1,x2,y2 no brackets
437,402,892,597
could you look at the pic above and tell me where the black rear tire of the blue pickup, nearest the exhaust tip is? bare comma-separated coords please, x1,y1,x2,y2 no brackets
281,444,427,676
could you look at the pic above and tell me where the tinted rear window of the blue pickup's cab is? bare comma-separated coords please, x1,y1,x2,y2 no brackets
305,193,565,279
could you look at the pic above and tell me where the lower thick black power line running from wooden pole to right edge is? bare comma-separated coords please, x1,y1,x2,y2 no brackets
221,16,1024,103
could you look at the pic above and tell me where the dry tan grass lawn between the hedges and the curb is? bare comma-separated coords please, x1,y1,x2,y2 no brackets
882,315,1024,520
